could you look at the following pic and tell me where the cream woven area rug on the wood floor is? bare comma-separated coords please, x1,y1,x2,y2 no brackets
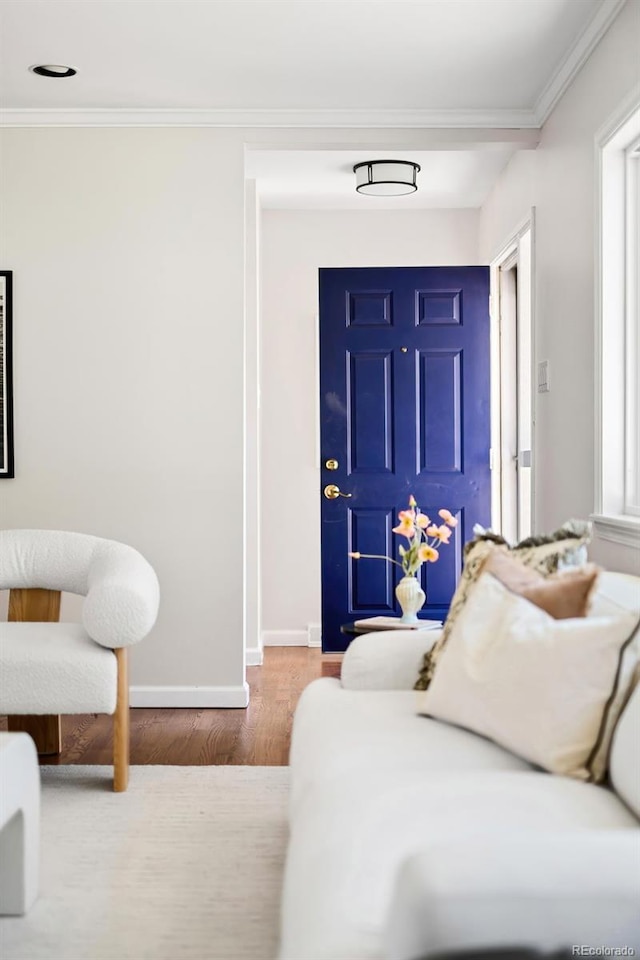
0,766,289,960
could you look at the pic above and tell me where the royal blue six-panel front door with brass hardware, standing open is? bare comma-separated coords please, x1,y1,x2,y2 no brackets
320,267,491,652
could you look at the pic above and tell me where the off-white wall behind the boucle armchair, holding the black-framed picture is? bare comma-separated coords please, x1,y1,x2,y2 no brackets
0,128,246,706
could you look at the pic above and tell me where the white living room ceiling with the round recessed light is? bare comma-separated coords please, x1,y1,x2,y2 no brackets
0,0,608,115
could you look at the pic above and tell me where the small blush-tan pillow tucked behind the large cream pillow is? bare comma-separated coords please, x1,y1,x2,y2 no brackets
483,548,598,620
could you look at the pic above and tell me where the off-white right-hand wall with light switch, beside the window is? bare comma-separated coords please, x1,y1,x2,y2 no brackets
480,0,640,572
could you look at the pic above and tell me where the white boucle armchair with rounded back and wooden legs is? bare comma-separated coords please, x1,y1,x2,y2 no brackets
0,530,160,791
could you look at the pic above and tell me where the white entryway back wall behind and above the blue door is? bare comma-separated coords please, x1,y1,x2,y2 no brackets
261,210,478,643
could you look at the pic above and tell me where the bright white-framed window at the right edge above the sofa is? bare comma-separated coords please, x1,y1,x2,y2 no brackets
593,95,640,545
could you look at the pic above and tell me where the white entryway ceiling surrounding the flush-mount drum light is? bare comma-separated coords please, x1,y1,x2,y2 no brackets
245,144,514,210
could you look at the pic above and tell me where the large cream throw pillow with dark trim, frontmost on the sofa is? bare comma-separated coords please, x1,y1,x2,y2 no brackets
419,573,636,780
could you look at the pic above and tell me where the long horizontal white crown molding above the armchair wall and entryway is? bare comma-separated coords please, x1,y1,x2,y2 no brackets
0,109,538,129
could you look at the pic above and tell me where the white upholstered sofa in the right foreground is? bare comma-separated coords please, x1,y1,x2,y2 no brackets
279,573,640,960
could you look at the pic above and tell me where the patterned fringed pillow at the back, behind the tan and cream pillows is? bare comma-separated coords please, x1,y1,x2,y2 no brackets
414,521,591,690
